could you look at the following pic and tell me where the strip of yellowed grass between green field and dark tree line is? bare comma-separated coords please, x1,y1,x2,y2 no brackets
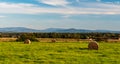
0,38,120,42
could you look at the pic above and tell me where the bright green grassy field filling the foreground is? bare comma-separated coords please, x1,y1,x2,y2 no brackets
0,42,120,64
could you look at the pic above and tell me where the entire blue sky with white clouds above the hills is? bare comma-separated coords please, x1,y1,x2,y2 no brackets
0,0,120,31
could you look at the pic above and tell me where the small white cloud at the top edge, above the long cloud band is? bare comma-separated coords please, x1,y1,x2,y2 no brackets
38,0,69,6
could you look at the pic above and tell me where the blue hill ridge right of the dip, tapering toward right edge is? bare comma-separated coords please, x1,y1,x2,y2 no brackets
42,28,120,33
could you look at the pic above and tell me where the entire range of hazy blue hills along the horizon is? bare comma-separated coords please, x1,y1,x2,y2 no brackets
0,27,120,33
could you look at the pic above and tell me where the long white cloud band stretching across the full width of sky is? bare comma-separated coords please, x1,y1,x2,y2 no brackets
0,3,120,14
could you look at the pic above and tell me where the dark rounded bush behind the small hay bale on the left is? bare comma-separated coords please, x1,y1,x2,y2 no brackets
16,33,38,41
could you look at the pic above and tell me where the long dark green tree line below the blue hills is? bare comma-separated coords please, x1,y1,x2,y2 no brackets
0,32,120,40
